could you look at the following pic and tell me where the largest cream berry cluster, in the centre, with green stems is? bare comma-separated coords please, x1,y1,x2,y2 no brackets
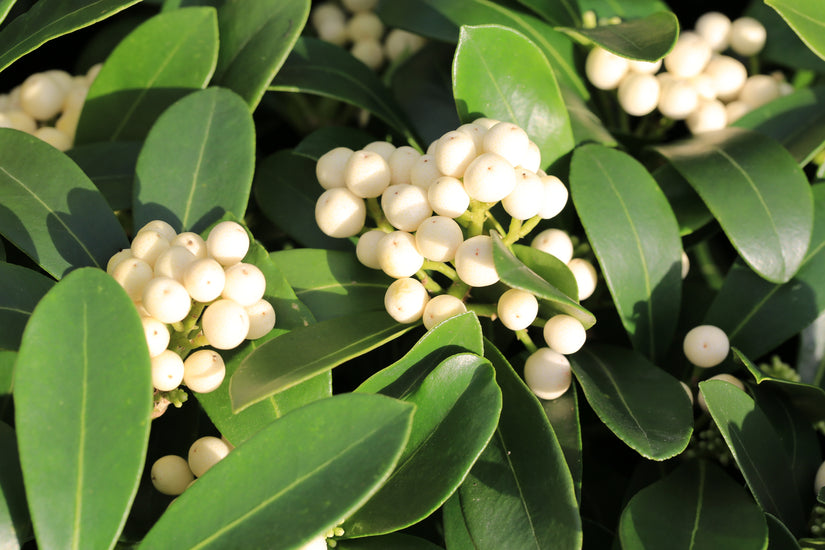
315,118,596,399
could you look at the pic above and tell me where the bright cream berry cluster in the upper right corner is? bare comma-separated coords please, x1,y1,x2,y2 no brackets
585,12,793,134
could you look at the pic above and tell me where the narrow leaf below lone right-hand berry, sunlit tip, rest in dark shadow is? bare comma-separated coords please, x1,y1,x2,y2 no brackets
699,380,805,535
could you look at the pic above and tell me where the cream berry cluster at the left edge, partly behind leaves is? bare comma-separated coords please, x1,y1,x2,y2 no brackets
0,64,100,151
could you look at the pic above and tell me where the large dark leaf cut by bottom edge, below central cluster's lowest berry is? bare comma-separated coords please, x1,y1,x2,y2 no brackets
444,342,582,550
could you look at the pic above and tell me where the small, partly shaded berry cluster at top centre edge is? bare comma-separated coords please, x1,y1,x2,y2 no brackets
311,0,424,70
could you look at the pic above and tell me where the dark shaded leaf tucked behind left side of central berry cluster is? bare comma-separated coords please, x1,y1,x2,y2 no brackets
252,150,354,251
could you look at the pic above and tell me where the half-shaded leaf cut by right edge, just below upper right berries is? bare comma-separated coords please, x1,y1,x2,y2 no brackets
733,86,825,166
